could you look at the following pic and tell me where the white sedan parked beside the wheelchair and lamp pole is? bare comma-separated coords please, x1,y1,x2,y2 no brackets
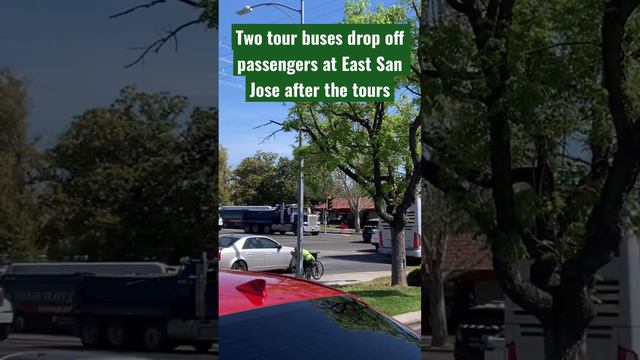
218,234,295,271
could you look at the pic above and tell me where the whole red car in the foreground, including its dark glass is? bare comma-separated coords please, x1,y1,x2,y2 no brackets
219,271,420,360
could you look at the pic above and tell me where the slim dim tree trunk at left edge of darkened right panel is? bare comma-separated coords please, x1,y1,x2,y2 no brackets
428,269,449,346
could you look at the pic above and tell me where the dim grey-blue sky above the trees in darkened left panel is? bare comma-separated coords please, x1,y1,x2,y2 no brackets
0,0,218,147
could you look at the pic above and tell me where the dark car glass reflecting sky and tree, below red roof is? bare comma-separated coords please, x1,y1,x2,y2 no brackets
219,296,420,360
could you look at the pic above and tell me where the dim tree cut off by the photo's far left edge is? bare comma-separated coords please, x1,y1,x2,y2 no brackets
0,69,40,261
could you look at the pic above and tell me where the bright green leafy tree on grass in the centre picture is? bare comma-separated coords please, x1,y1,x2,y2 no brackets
273,0,421,286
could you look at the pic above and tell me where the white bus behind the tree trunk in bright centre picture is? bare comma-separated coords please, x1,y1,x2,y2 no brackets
371,196,422,258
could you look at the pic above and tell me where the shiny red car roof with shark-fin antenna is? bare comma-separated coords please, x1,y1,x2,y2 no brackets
218,270,345,316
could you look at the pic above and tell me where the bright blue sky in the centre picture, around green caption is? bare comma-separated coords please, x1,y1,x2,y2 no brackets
218,0,395,167
